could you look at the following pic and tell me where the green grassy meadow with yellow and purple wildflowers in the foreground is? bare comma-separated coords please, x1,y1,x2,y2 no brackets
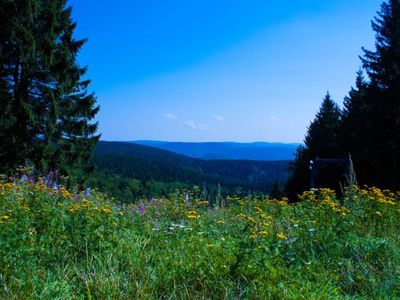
0,178,400,299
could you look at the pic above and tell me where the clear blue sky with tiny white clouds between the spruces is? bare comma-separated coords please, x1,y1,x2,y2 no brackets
70,0,381,142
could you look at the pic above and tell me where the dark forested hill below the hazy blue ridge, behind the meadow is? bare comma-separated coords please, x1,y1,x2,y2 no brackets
93,141,289,199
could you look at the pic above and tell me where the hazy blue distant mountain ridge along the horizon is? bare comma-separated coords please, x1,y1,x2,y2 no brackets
131,140,301,161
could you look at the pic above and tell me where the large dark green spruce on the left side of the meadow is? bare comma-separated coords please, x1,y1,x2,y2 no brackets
0,0,99,183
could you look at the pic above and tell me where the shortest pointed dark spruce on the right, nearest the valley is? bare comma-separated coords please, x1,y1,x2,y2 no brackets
286,93,341,201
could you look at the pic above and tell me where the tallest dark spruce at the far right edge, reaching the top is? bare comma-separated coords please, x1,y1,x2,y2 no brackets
361,0,400,189
